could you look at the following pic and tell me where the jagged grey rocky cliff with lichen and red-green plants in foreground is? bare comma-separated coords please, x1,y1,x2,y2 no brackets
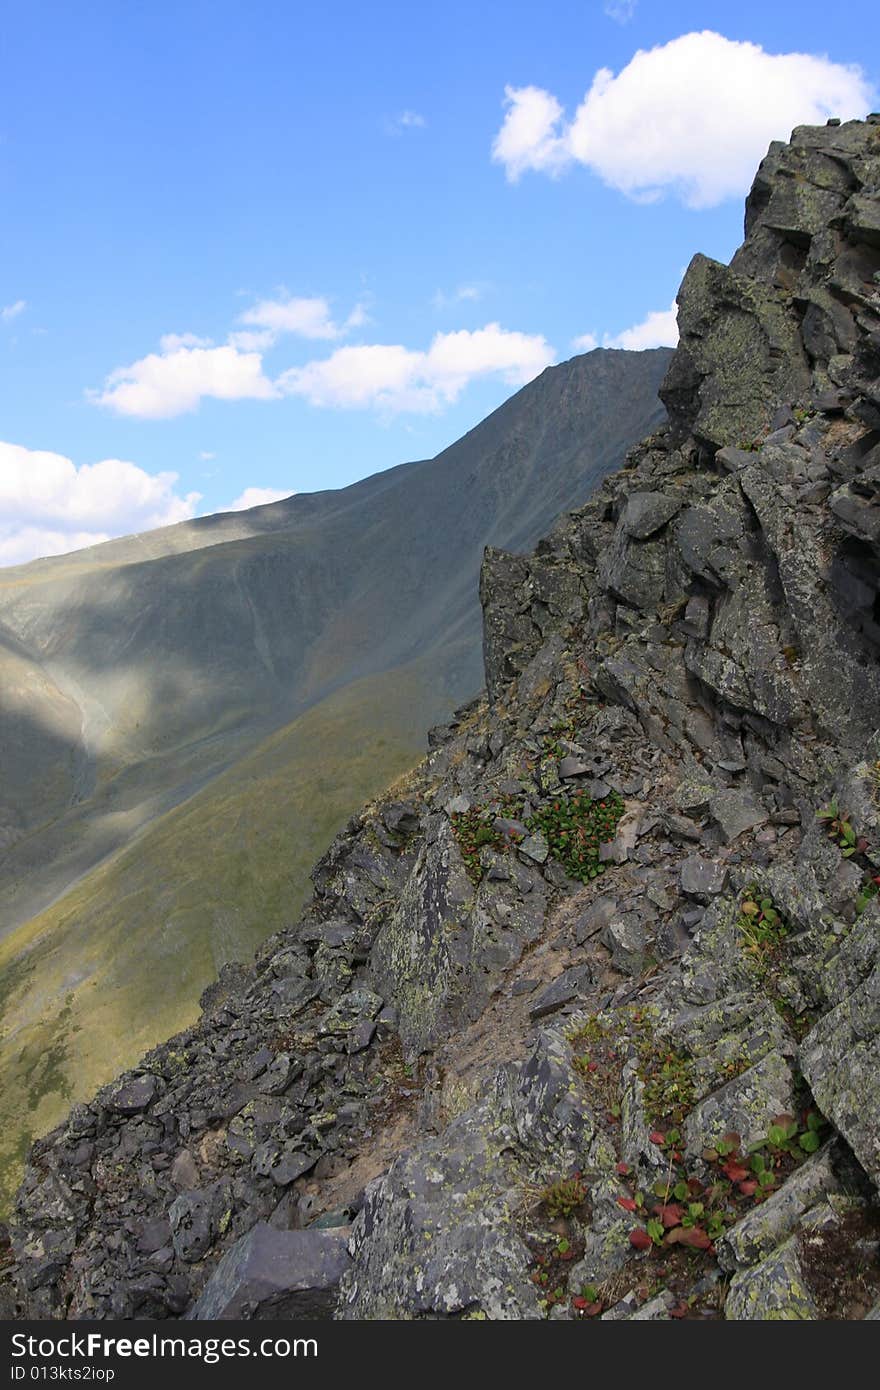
6,117,880,1319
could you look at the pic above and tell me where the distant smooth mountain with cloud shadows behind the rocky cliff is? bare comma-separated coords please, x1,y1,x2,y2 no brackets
0,350,670,1206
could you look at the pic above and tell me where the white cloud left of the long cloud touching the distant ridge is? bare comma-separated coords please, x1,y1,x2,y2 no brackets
90,338,277,420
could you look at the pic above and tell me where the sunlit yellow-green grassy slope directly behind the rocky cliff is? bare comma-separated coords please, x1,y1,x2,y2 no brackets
0,656,445,1207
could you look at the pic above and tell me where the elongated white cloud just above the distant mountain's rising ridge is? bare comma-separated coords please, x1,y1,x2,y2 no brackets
278,324,555,413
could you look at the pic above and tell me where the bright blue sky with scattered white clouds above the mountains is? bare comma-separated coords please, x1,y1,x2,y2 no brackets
0,0,880,563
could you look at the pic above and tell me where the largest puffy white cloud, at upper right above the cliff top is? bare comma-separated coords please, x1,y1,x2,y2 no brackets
492,31,873,209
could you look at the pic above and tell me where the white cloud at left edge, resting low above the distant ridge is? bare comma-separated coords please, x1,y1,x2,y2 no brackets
0,442,200,564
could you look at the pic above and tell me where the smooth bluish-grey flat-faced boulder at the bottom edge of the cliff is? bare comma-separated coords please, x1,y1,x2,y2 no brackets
186,1222,350,1321
